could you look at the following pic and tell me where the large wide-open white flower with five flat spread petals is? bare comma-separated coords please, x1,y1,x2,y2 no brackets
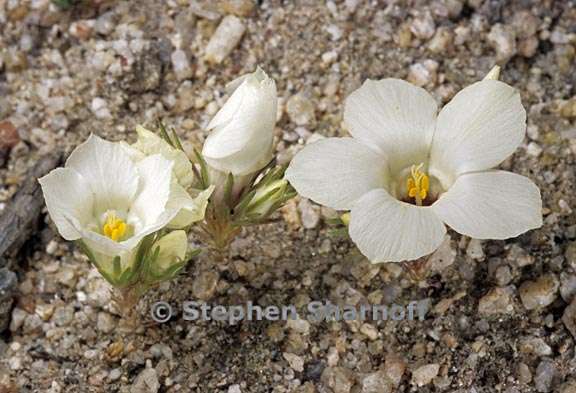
286,79,542,262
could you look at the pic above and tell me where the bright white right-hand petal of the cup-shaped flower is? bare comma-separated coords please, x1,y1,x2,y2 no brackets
129,154,173,227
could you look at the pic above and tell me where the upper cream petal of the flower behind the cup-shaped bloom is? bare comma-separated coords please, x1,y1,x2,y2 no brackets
132,126,194,187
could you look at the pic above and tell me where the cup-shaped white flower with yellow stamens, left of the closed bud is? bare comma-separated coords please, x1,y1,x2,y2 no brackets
39,135,209,275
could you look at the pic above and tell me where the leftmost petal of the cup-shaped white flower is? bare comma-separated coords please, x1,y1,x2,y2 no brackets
38,168,94,240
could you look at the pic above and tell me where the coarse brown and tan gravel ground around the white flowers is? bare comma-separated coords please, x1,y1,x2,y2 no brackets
0,0,576,393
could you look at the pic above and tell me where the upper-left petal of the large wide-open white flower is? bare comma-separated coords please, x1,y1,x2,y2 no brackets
344,79,438,173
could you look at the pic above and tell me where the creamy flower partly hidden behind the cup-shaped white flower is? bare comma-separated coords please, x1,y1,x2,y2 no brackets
120,126,214,228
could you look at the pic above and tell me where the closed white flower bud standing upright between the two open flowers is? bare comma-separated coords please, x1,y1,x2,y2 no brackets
202,68,278,176
